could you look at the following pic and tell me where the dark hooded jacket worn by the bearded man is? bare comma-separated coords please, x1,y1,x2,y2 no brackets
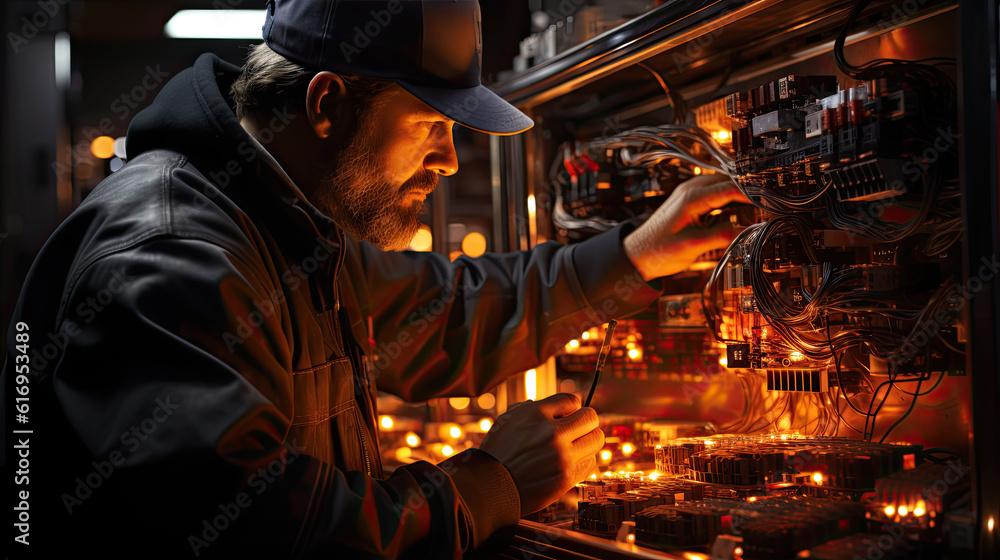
3,51,658,558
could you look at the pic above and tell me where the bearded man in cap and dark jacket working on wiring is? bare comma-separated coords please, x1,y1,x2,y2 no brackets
4,0,741,558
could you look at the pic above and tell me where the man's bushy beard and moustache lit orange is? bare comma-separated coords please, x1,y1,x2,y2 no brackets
311,116,438,251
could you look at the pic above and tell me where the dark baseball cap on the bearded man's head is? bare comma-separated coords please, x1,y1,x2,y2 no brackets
263,0,534,134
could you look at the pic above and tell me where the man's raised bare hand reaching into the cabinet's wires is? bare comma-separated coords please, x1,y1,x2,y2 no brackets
624,175,750,281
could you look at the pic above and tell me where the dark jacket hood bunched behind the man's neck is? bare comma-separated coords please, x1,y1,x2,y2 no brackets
125,53,248,163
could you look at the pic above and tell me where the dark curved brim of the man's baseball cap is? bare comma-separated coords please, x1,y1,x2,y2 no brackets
396,80,535,135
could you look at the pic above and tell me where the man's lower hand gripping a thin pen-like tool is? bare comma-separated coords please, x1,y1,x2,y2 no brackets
479,393,604,515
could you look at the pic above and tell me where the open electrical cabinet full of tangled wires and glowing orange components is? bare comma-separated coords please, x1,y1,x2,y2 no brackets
492,2,977,559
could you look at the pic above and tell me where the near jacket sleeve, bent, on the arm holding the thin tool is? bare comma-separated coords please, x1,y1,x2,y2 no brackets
15,238,519,558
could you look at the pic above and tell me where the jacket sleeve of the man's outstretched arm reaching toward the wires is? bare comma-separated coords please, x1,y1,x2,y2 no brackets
347,223,661,401
